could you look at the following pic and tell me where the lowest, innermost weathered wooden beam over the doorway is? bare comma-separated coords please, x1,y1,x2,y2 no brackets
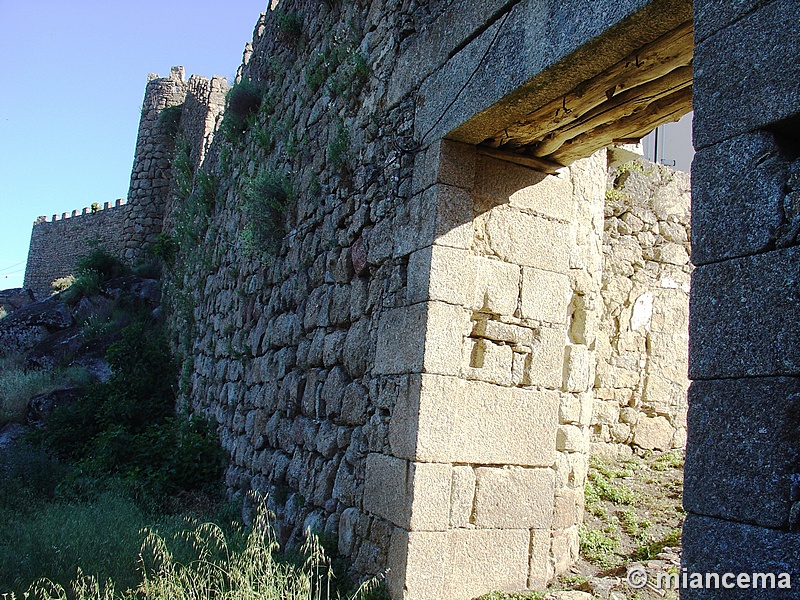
547,87,692,165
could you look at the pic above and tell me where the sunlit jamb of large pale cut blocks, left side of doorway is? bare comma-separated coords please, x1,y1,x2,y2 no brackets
364,141,606,598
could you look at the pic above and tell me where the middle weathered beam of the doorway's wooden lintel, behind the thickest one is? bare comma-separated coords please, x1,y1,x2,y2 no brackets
533,67,692,157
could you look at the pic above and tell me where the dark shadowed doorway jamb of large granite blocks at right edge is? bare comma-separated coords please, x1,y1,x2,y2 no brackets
682,0,800,600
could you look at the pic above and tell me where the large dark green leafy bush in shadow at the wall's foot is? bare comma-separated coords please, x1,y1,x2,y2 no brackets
41,321,224,503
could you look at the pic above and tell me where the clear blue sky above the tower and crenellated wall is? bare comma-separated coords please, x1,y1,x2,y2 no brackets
0,0,266,289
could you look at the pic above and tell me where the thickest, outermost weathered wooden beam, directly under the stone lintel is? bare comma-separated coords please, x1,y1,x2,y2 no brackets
492,22,694,146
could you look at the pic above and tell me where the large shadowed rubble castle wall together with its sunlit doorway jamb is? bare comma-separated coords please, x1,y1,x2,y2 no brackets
161,0,687,598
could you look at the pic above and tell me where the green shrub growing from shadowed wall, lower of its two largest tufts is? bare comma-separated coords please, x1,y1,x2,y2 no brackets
242,170,294,256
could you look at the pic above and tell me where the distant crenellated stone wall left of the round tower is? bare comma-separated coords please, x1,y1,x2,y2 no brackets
23,200,131,299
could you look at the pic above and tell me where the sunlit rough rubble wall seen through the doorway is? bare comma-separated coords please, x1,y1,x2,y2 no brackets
592,150,692,456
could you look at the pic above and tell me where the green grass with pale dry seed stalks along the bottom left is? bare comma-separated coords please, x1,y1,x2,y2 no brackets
0,495,388,600
